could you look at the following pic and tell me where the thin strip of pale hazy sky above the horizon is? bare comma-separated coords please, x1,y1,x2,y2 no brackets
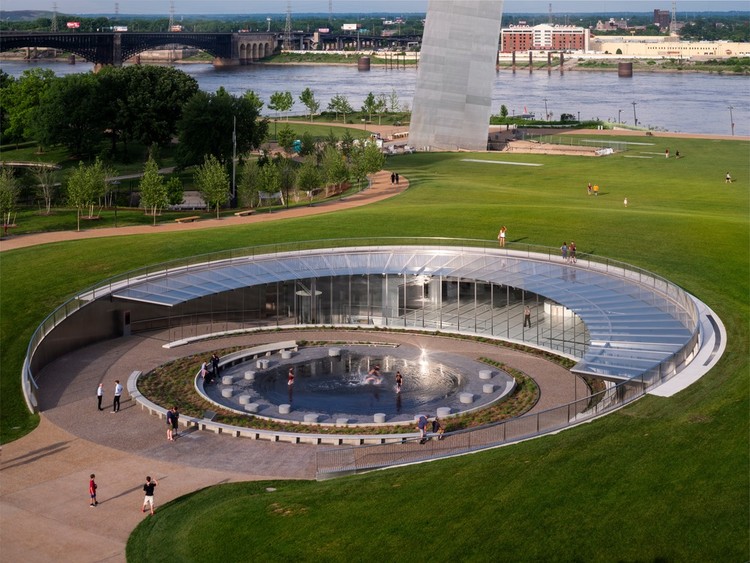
0,0,750,17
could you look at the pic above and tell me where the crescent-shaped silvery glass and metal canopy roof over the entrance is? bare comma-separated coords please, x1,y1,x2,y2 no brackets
113,246,699,380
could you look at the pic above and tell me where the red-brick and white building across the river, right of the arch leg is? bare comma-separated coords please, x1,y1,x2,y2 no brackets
500,24,590,53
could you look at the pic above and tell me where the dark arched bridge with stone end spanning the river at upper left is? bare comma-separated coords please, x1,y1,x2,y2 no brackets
0,32,279,66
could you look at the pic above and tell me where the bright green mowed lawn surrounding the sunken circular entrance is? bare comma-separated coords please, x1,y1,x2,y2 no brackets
0,137,750,561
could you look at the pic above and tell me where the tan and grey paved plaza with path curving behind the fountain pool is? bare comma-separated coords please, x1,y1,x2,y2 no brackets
0,331,585,562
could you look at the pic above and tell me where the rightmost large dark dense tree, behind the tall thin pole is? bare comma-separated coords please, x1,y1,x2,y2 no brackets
177,88,268,166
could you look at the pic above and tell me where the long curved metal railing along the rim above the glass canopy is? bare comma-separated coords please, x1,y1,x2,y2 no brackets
21,237,698,412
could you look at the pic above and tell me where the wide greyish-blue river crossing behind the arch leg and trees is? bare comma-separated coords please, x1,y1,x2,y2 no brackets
0,61,750,136
